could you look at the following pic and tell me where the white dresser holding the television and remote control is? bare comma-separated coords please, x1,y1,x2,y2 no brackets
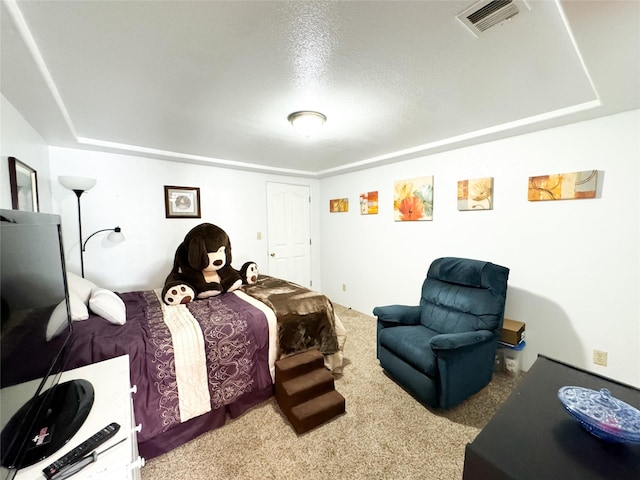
15,355,144,480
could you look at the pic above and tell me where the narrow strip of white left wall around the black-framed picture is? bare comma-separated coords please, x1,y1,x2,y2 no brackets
0,95,51,213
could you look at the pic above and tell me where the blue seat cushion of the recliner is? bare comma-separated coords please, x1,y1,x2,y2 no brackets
378,325,438,378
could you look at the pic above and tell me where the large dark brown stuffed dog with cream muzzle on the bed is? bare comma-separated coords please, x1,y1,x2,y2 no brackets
162,223,245,305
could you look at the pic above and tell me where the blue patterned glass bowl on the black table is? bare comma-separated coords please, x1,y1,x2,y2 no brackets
558,386,640,443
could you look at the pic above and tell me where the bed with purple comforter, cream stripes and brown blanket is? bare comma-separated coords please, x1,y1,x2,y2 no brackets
60,275,346,459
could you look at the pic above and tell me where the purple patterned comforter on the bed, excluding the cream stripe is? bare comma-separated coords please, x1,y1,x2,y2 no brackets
68,291,273,458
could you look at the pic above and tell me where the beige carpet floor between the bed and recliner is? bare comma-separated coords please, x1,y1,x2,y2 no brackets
142,305,519,480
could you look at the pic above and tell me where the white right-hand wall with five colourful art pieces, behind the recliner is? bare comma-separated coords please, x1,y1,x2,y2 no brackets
320,110,640,385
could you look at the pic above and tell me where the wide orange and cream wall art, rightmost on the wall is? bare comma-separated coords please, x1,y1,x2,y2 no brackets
528,170,598,202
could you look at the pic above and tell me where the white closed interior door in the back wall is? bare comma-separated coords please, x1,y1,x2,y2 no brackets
267,183,311,287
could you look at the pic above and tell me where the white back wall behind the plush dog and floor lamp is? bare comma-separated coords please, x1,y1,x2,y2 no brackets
50,147,320,291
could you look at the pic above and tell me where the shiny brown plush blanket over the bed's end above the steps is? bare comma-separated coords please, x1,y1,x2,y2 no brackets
242,275,338,355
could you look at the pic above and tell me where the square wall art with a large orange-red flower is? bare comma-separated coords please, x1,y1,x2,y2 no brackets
393,175,433,222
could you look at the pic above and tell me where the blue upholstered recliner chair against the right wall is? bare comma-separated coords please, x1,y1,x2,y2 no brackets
373,257,509,409
